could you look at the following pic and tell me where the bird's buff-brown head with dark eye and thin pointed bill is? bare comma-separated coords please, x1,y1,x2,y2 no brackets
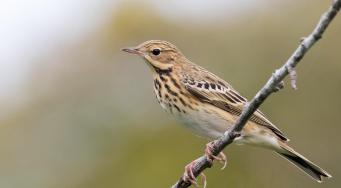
122,40,184,71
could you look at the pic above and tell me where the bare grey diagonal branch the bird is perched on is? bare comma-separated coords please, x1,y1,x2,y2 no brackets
172,0,341,188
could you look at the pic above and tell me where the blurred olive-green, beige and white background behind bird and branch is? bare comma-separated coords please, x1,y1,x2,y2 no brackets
0,0,341,188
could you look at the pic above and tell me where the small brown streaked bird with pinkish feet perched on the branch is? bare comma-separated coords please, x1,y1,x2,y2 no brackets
122,40,332,184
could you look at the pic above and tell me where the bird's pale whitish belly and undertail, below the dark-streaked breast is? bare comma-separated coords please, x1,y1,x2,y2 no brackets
154,78,280,150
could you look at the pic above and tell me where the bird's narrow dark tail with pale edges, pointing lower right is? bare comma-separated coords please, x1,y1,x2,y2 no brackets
276,142,332,183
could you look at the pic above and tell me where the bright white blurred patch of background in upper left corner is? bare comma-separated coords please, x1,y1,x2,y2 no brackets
0,0,114,114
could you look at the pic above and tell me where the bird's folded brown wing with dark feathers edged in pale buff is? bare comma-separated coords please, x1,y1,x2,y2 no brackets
181,72,288,141
